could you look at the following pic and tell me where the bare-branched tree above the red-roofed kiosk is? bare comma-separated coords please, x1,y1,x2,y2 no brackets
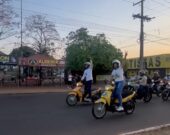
25,15,59,54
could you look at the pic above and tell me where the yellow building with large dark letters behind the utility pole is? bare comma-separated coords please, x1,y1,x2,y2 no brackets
127,54,170,77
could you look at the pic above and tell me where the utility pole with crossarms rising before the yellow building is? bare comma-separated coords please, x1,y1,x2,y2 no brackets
133,0,155,70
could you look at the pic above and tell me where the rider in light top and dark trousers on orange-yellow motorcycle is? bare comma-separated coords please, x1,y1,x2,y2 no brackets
81,60,93,101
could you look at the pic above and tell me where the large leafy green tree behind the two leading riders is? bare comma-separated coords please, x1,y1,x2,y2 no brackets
66,28,122,77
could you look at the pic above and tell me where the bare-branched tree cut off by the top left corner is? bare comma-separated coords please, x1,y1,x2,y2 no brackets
0,0,17,40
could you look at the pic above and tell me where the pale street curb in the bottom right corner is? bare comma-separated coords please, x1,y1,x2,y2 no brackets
120,124,170,135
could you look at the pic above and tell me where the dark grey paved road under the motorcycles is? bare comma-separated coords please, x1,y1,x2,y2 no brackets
0,93,170,135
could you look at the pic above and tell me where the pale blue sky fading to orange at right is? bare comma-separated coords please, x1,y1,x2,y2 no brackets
0,0,170,58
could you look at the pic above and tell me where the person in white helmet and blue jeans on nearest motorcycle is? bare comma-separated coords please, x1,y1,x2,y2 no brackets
111,60,124,111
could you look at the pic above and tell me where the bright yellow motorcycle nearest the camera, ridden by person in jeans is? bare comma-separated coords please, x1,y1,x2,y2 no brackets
92,82,136,119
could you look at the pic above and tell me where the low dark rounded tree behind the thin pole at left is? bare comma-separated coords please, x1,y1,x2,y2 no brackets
10,46,35,61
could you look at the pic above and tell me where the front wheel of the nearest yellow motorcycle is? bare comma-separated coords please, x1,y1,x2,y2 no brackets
92,103,106,119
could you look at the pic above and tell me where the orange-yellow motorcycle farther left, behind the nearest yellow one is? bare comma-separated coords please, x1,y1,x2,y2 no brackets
66,82,102,106
